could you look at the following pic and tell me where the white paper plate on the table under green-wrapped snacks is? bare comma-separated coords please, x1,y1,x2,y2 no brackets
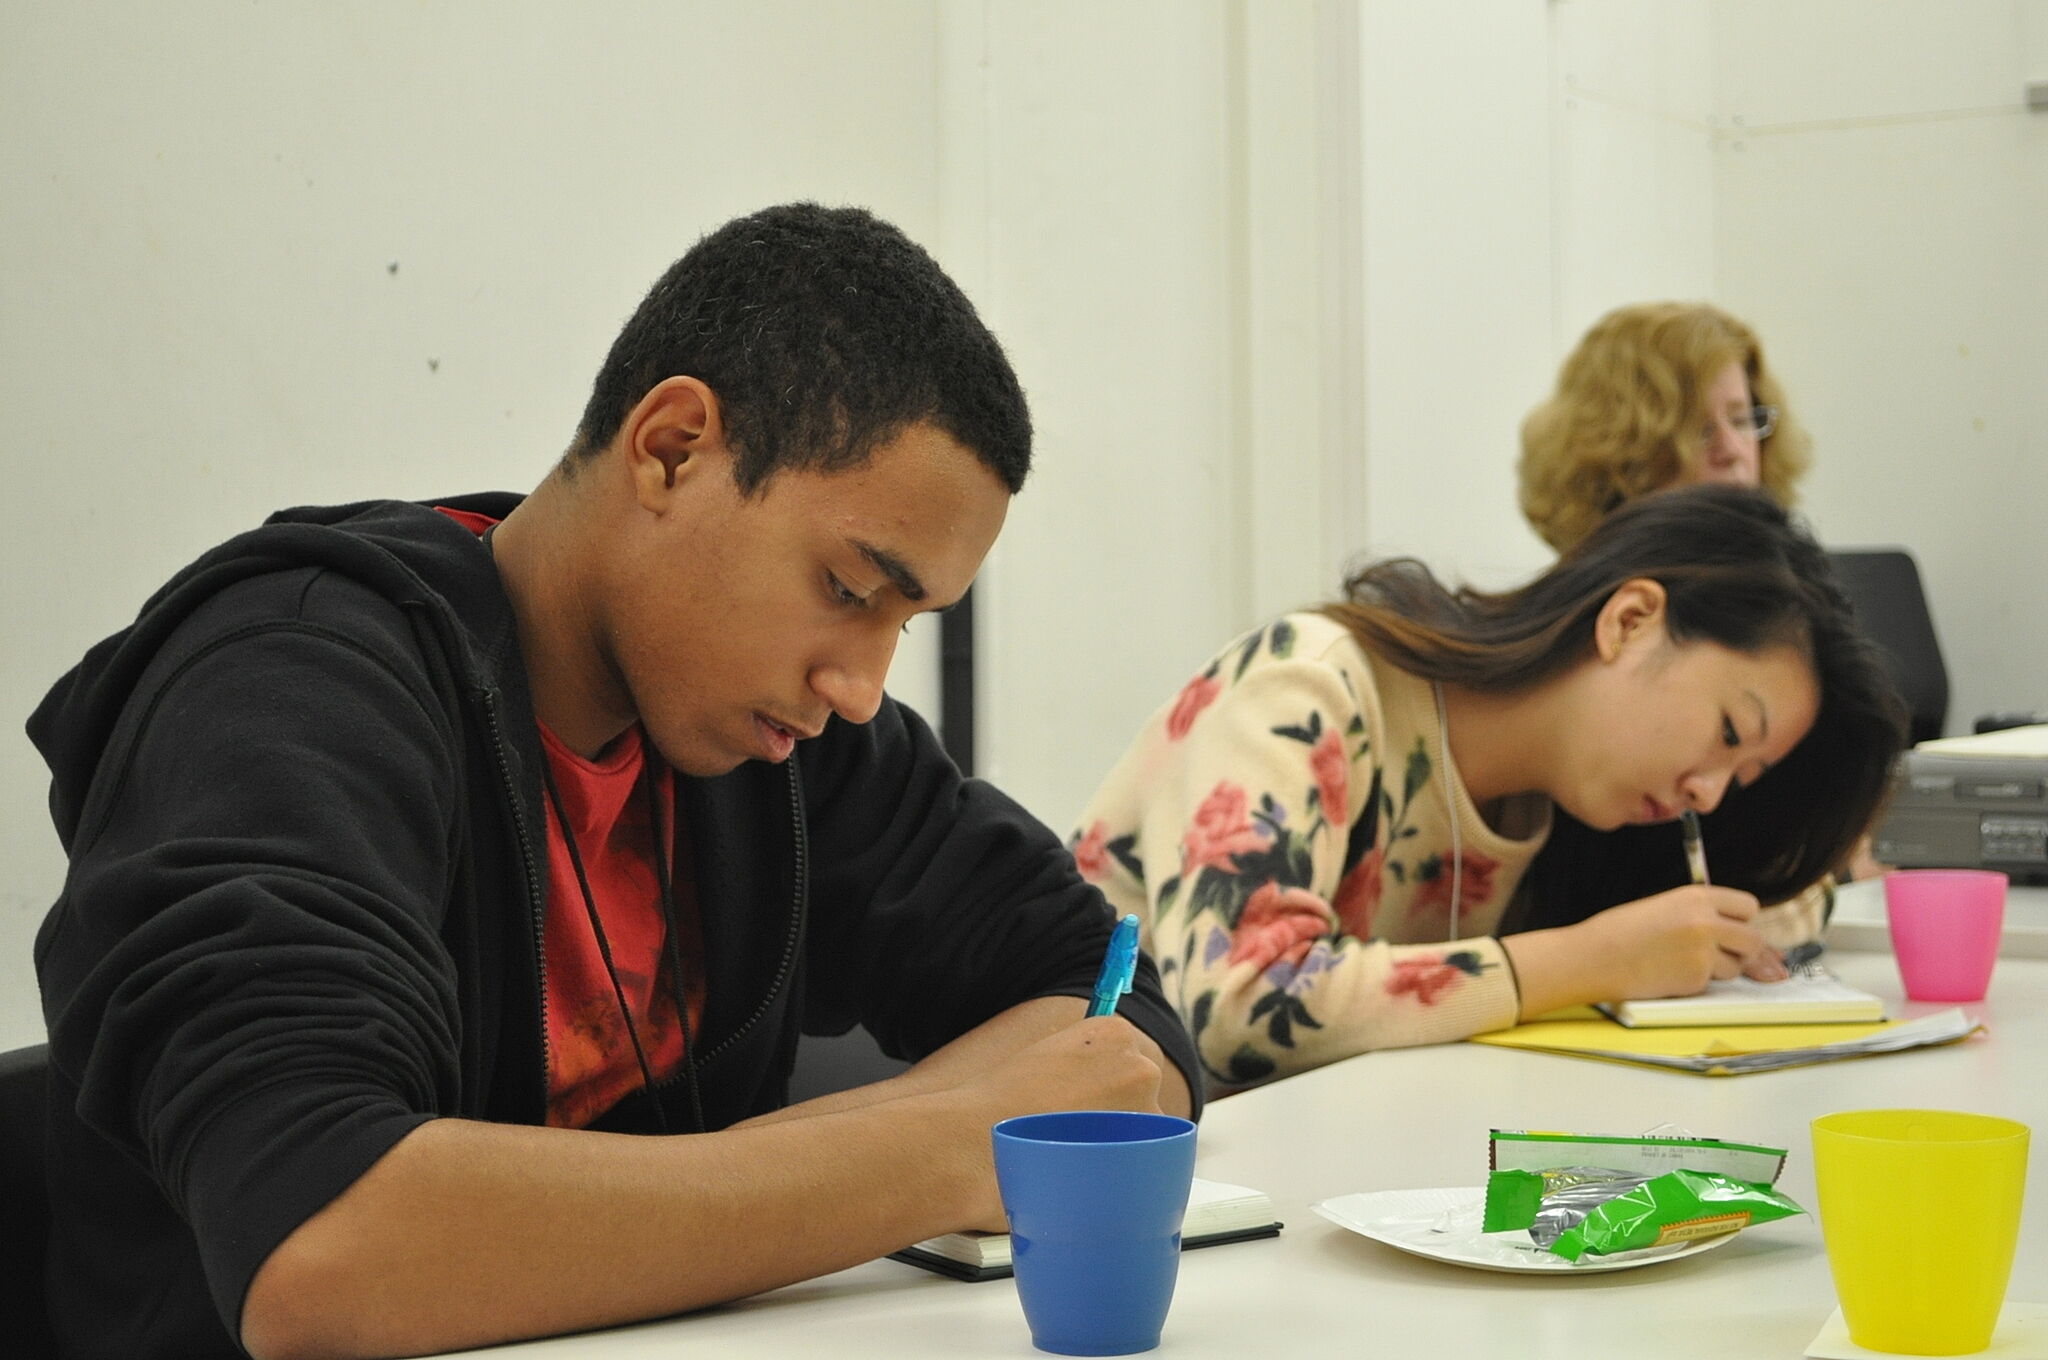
1309,1186,1735,1274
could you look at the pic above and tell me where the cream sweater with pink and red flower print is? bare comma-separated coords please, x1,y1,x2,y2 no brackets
1069,614,1819,1090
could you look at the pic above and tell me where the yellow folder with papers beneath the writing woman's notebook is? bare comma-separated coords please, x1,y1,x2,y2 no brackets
1473,1008,1982,1077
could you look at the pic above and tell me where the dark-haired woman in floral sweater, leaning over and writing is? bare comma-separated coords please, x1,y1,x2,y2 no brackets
1071,487,1903,1090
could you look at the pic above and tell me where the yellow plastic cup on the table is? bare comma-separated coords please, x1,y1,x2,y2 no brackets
1812,1110,2028,1356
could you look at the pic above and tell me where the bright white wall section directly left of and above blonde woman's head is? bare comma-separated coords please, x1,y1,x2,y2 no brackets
1354,0,1714,588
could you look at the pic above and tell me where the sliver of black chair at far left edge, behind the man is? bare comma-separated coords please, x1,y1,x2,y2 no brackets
0,1045,57,1360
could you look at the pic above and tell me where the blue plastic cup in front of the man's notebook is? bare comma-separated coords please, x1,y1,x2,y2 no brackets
993,1110,1194,1356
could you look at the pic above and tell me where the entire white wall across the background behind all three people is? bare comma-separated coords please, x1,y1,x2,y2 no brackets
0,0,2048,1045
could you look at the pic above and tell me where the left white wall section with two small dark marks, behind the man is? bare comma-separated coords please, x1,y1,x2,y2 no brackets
0,0,946,1045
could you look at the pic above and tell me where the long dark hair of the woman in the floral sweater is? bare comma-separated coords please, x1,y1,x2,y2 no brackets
1323,485,1907,909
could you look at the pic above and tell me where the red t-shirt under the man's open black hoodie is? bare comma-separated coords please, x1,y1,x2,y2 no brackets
440,506,705,1129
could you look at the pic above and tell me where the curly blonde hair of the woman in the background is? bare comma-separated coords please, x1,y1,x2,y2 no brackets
1518,303,1812,553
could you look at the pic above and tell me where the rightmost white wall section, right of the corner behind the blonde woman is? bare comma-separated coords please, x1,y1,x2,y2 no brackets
1714,0,2048,731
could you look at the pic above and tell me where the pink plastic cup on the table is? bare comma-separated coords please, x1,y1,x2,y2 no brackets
1884,868,2005,1002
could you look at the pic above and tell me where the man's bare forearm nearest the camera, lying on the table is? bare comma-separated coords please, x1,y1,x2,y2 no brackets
242,1096,985,1360
